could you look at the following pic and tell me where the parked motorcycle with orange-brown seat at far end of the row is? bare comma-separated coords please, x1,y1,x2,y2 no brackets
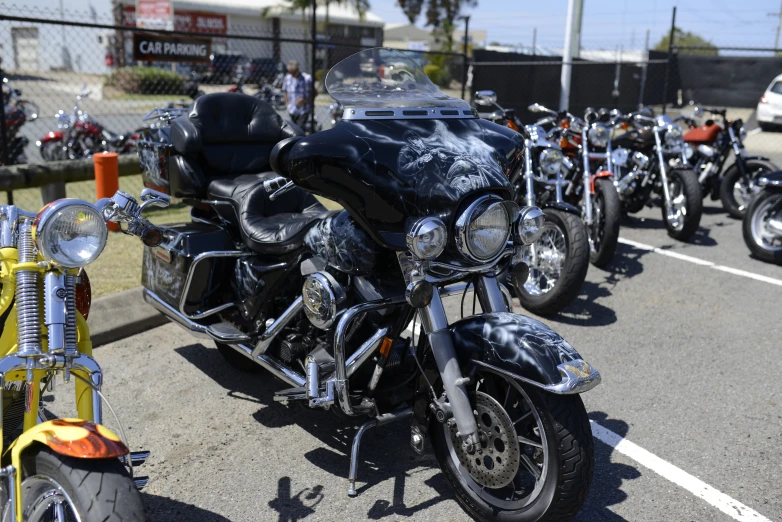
677,106,777,218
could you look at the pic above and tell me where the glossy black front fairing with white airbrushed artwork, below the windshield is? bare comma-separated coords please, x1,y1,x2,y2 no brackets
285,119,523,250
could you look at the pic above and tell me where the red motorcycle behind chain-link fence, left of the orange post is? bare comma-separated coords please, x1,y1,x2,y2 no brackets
35,91,141,161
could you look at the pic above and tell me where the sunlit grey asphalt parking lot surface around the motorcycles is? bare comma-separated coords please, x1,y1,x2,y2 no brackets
58,196,782,522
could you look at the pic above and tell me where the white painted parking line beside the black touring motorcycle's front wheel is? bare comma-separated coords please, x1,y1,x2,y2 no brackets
590,421,771,522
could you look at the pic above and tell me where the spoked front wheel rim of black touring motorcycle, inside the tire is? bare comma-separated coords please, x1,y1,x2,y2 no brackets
445,366,549,510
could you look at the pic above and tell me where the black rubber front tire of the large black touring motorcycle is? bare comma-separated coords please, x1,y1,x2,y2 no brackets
429,370,594,522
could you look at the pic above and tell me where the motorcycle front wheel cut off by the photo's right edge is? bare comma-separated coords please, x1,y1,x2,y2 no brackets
742,171,782,265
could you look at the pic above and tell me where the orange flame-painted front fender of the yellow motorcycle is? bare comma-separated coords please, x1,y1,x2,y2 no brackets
6,419,130,520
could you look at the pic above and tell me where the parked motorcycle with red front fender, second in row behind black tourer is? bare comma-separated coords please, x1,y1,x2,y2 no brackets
527,103,622,268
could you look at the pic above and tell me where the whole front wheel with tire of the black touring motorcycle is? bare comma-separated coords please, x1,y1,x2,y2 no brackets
432,370,594,522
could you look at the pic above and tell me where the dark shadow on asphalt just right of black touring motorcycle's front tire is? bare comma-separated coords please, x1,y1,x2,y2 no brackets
575,412,641,522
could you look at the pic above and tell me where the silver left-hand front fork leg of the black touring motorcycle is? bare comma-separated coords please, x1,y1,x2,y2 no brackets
421,288,480,450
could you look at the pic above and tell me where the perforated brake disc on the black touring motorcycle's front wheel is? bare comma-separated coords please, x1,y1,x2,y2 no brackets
451,392,521,489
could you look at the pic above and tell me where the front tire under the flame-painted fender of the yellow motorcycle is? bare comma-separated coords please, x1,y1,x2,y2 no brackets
21,446,146,522
